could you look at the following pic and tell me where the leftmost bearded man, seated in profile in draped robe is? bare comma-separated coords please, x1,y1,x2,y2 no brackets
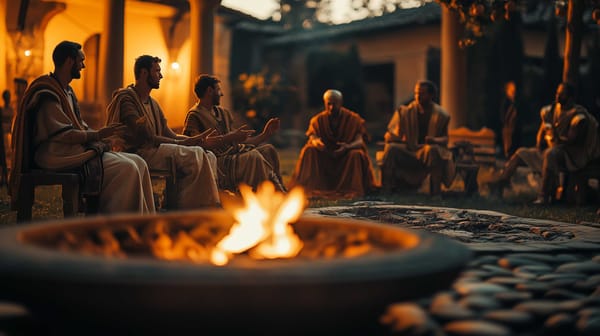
10,41,154,213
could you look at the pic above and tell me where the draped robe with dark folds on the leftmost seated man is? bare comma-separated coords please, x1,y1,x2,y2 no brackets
11,75,155,213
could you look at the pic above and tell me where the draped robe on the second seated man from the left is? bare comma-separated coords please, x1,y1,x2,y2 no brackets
107,86,220,209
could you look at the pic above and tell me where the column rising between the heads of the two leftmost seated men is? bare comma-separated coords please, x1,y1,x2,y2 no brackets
98,0,125,110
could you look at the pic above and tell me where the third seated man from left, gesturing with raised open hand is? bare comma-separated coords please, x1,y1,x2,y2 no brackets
183,75,285,191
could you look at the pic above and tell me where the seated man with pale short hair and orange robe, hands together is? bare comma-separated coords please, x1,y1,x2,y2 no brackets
291,90,375,197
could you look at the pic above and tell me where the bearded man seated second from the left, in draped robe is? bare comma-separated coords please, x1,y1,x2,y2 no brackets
107,55,219,209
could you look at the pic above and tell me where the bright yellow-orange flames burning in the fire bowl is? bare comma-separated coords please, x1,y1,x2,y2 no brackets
211,182,305,266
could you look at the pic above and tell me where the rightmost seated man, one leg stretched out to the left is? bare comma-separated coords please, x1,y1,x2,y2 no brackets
492,83,600,204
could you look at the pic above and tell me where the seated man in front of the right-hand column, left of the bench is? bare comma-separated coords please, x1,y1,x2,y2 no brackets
381,81,455,195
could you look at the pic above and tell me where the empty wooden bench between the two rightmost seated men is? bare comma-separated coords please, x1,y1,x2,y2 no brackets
448,127,496,195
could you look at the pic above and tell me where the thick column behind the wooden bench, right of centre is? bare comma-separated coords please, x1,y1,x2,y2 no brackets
440,6,468,129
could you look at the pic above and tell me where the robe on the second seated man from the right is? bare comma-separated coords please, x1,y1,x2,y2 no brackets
381,101,456,190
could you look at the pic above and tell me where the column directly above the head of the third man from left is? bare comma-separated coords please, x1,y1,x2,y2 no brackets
189,0,221,91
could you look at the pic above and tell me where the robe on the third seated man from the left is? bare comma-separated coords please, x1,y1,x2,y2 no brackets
183,103,285,192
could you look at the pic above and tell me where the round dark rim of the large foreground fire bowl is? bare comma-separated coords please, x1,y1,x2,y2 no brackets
0,210,471,285
